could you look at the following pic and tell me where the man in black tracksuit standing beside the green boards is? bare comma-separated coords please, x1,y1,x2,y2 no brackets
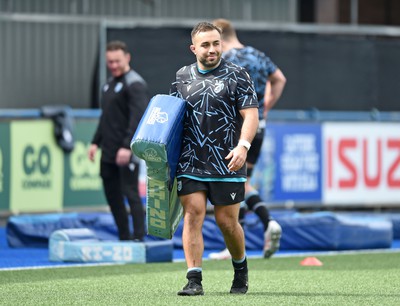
88,41,149,241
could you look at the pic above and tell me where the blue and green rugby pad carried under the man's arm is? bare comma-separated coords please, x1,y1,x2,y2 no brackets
131,95,186,239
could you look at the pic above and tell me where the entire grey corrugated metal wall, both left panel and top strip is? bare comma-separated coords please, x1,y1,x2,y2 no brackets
0,0,297,108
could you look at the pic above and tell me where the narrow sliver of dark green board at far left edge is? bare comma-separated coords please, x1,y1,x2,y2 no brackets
0,122,10,211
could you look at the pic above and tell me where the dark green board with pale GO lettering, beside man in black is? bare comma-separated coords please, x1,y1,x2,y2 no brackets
64,119,107,208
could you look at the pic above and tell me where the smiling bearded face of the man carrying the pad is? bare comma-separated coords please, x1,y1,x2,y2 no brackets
190,30,222,70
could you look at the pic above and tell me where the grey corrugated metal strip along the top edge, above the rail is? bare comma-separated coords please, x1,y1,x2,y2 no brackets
0,0,298,22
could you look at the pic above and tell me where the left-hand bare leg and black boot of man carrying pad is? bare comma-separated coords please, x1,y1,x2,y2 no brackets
178,191,207,295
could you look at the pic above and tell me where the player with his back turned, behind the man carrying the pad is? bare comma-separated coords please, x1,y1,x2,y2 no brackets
210,19,286,259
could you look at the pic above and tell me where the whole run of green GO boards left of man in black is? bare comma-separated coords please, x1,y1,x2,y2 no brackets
0,119,106,213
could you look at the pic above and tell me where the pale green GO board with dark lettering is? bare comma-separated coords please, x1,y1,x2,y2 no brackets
10,120,64,213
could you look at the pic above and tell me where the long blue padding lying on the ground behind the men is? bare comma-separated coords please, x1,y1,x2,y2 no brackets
7,211,394,250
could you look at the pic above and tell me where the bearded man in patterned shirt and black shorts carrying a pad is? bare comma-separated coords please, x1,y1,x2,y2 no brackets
170,22,258,295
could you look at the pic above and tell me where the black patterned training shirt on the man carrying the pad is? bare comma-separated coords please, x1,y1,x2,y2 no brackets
170,60,258,181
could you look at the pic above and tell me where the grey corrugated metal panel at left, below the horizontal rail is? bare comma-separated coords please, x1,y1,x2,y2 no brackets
0,19,99,108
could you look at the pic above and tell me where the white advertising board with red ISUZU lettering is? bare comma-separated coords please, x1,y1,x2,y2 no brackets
322,122,400,205
